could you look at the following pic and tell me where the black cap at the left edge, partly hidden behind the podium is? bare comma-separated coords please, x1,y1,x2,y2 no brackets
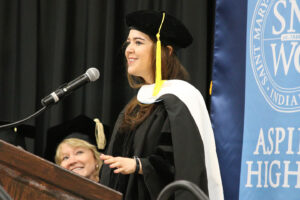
0,121,36,153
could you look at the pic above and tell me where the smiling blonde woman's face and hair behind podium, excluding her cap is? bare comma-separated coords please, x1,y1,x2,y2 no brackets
55,138,102,182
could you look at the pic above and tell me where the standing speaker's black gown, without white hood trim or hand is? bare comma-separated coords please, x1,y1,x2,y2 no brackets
100,94,208,200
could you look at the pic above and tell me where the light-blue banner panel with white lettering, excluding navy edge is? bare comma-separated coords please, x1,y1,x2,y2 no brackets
239,0,300,200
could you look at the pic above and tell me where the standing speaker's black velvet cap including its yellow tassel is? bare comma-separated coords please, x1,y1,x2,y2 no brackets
126,10,193,96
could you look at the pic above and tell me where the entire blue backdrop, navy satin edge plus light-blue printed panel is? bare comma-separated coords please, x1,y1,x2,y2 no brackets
211,0,300,200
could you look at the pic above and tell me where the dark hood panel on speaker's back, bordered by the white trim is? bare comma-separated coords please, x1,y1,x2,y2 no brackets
161,94,208,200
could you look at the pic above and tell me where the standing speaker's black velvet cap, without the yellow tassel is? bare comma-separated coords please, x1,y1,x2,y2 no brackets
126,10,193,48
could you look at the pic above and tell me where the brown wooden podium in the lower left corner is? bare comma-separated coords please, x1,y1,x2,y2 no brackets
0,140,122,200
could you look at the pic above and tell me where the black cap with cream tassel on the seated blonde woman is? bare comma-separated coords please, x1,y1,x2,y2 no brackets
45,115,106,162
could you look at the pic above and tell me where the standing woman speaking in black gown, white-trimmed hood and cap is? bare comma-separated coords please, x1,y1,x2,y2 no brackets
100,11,223,200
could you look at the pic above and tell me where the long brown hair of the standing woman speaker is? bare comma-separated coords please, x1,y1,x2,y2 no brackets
120,40,189,131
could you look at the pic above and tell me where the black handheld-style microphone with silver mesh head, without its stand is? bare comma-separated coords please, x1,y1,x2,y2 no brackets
41,68,100,106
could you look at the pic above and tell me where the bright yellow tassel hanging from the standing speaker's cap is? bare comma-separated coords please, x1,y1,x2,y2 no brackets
153,13,165,96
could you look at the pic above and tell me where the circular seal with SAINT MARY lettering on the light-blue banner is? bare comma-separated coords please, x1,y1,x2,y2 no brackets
249,0,300,112
